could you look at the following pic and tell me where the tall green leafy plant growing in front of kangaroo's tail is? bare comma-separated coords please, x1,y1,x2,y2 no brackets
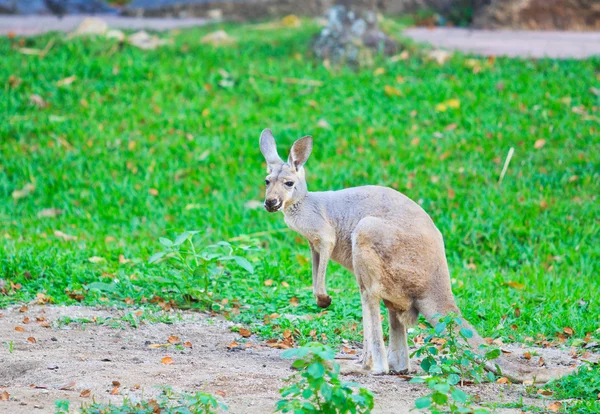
411,314,501,413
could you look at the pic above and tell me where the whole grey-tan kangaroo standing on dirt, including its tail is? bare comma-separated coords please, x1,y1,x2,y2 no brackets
260,129,570,383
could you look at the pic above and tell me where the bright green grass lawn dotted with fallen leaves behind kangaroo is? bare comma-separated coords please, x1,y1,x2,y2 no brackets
0,18,600,408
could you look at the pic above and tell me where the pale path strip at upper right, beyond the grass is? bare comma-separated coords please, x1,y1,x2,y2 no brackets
404,28,600,59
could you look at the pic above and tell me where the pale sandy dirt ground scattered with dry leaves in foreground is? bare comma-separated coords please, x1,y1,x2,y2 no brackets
0,305,597,414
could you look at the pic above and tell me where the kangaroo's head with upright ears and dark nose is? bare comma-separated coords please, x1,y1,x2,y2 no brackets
260,129,312,213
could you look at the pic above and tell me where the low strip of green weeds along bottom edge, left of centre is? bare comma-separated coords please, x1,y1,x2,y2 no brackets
80,387,227,414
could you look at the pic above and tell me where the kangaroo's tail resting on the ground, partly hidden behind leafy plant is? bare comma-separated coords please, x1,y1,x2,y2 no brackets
420,306,573,384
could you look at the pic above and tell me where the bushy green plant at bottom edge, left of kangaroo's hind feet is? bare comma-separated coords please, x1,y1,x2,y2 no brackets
276,342,374,414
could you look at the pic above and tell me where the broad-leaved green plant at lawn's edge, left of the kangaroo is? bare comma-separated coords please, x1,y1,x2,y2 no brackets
148,231,255,308
